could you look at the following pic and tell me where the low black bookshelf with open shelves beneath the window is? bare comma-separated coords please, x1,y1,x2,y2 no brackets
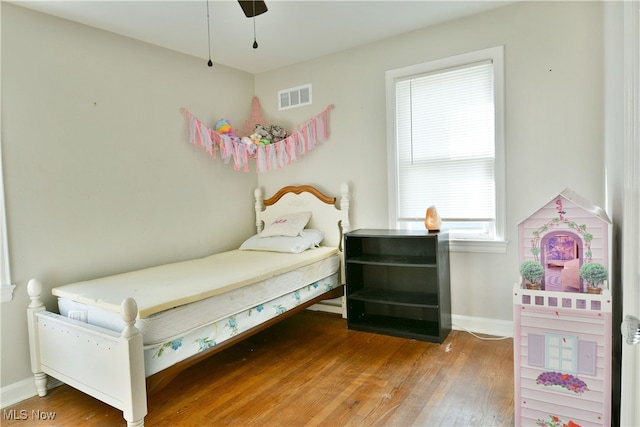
345,229,451,343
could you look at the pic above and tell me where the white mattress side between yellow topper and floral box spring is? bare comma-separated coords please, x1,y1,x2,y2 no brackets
58,251,340,345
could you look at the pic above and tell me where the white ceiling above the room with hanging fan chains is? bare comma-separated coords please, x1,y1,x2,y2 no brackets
13,0,514,73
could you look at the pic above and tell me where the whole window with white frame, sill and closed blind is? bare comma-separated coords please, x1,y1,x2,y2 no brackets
386,46,506,251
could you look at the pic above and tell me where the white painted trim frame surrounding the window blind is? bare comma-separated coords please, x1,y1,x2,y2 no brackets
385,45,507,253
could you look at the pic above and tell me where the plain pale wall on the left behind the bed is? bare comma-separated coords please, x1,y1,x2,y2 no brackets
0,2,257,396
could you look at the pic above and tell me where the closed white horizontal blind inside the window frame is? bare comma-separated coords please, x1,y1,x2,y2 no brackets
396,62,496,226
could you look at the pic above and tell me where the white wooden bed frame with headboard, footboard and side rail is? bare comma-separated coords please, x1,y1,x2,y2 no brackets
27,184,351,426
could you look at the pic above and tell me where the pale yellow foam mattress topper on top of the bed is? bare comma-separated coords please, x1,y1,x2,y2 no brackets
52,247,338,318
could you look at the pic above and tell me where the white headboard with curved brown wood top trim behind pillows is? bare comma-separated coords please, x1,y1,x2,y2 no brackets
254,184,351,251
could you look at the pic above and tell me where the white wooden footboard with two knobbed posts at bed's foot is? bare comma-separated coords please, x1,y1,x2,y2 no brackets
27,279,147,426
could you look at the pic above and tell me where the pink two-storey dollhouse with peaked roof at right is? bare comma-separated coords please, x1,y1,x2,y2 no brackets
513,190,612,427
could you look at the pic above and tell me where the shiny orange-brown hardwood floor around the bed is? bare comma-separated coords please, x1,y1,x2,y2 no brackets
0,311,513,427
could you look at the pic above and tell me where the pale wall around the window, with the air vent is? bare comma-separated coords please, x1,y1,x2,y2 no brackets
256,2,605,332
